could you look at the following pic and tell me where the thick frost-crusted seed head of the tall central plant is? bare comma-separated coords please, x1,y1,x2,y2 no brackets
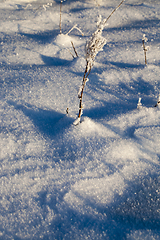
85,15,106,71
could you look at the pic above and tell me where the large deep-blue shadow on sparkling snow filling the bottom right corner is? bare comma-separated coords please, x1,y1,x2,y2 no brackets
29,174,160,240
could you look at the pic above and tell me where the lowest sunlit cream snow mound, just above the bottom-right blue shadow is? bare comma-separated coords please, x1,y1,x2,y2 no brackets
64,173,125,212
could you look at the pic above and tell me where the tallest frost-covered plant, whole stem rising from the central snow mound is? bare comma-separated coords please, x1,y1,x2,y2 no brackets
74,0,125,125
